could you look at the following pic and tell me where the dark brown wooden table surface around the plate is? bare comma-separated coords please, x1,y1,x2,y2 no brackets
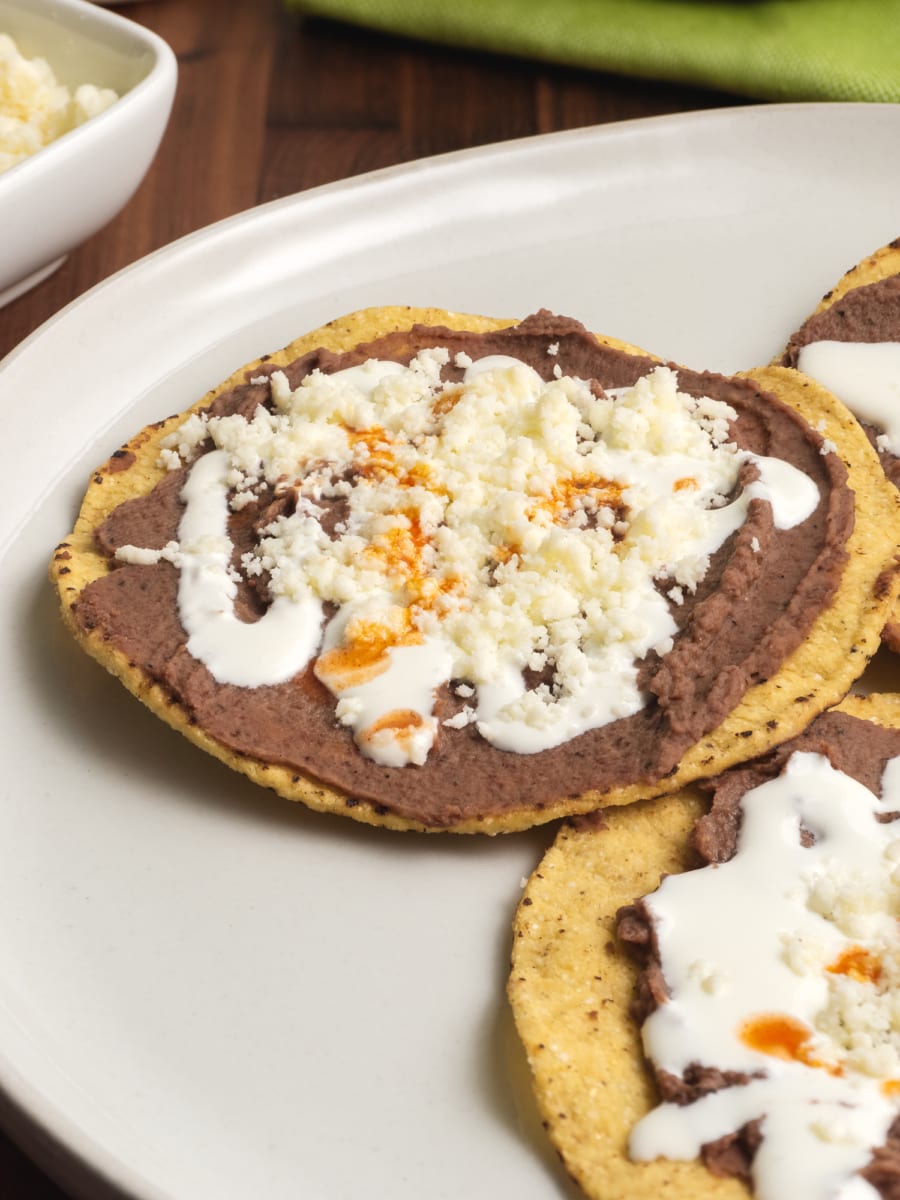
0,0,744,1200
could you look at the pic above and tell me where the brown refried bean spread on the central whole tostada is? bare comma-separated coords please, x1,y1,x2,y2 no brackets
74,312,853,828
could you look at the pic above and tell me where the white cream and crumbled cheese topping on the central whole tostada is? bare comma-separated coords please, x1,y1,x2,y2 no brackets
120,349,818,766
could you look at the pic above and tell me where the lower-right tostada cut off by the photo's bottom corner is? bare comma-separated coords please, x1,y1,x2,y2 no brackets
509,695,900,1200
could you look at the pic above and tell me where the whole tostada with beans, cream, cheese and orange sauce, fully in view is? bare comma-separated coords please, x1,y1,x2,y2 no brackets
50,308,898,833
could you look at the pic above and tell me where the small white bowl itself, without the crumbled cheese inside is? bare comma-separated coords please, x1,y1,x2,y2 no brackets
0,0,178,305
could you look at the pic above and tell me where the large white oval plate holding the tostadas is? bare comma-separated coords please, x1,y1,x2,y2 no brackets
0,104,900,1200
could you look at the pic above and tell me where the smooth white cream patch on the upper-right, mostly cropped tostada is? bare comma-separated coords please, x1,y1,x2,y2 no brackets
797,341,900,456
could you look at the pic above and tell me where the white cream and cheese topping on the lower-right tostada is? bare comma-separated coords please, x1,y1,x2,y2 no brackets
630,754,900,1200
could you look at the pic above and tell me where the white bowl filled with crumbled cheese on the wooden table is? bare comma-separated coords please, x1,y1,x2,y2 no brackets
0,0,178,305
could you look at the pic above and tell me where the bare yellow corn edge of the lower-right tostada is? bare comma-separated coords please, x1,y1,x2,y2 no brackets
508,695,900,1200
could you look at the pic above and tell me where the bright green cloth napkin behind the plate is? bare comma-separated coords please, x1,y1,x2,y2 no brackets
284,0,900,101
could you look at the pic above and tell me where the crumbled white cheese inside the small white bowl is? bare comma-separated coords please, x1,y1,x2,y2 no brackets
0,34,119,172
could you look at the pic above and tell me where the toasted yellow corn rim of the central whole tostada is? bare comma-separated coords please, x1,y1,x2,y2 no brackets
49,307,900,834
